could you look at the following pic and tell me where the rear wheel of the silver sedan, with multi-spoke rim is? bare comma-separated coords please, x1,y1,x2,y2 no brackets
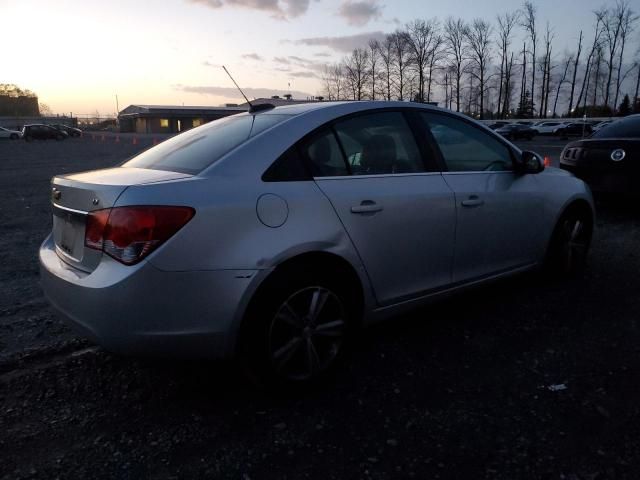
239,269,356,389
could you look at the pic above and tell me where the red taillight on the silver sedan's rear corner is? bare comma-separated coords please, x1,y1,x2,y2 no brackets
84,206,195,265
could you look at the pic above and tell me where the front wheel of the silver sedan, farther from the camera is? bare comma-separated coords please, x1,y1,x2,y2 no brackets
545,208,593,277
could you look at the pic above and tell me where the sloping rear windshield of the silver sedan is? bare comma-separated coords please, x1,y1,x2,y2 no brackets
122,114,289,175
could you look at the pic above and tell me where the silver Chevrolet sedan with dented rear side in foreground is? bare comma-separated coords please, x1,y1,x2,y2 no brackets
39,102,593,385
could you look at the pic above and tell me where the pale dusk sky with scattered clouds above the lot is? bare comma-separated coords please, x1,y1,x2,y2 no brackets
0,0,624,115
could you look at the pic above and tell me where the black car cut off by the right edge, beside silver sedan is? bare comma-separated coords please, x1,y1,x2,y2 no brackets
560,115,640,195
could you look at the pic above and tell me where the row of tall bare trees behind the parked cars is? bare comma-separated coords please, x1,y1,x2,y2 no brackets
322,0,640,119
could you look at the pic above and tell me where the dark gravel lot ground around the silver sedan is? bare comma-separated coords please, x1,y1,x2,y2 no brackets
0,137,640,480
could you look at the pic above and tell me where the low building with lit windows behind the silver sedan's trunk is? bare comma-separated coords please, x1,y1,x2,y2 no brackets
118,105,247,133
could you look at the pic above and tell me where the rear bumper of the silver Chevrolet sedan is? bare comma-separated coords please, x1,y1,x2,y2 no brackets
40,236,258,358
